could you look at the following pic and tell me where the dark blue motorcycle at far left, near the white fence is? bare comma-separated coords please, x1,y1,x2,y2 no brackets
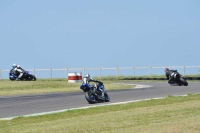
9,69,36,81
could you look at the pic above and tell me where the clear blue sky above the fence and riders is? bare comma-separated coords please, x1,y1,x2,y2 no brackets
0,0,200,70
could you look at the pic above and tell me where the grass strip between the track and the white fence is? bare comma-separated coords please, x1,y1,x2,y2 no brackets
0,79,135,96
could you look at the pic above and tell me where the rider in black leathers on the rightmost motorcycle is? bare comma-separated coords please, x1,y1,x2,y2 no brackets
165,68,181,85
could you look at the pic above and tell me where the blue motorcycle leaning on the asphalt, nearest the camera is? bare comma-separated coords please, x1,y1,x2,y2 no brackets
80,82,110,104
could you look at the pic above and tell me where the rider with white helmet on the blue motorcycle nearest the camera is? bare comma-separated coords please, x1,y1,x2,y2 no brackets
82,73,104,95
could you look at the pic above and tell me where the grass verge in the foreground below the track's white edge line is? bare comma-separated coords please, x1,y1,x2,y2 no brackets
0,94,200,133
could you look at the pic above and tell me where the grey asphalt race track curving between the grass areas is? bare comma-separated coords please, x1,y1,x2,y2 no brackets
0,82,200,120
